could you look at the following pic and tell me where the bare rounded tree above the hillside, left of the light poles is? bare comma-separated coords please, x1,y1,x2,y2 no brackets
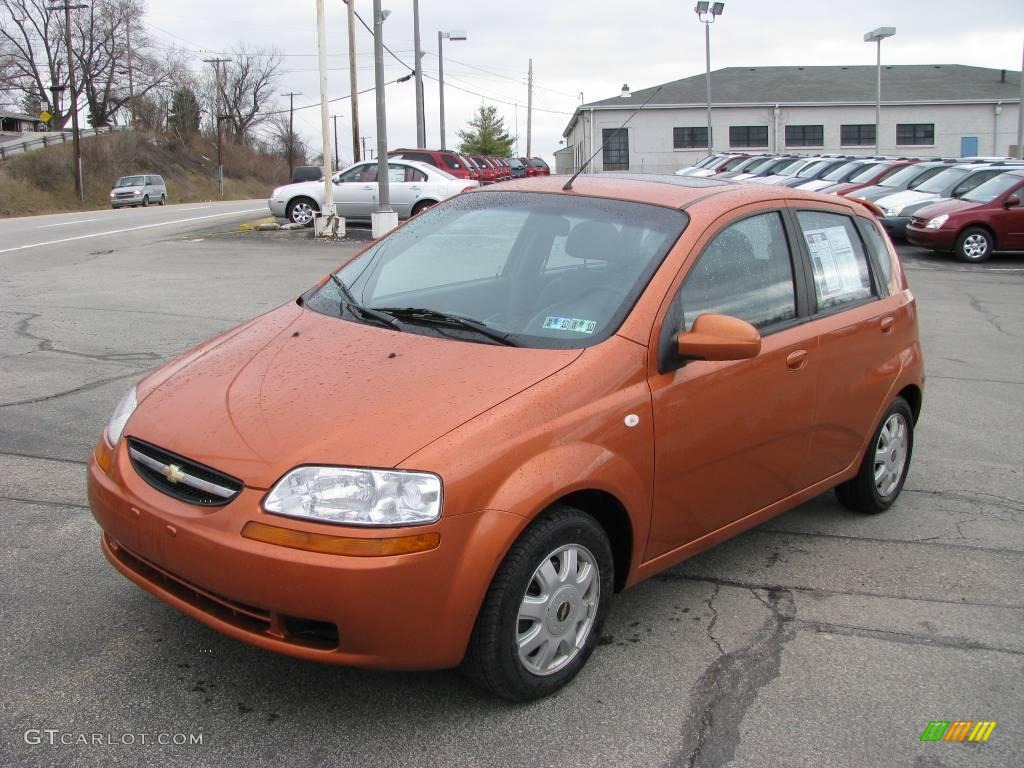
206,43,281,143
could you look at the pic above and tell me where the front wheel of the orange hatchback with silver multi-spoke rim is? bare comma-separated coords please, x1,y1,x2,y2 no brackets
463,505,614,701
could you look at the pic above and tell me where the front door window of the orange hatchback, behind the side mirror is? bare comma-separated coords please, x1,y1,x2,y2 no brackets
679,211,797,331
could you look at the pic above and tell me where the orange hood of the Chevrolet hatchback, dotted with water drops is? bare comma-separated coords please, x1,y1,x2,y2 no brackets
125,303,581,488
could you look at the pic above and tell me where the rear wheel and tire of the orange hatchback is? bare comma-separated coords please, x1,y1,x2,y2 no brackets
836,397,913,514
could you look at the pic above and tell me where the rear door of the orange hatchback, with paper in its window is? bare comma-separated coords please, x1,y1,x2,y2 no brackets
791,203,916,486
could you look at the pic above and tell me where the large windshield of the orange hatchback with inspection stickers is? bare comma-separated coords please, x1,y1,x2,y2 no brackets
304,191,689,348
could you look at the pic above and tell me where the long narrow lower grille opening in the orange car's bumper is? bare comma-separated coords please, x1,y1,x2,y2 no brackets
106,538,338,650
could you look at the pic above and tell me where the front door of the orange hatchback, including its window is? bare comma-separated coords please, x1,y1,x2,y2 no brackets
645,204,817,558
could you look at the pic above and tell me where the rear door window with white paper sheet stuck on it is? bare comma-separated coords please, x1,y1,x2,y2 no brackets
797,211,873,310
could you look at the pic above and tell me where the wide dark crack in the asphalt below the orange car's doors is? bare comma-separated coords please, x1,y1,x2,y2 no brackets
670,588,797,768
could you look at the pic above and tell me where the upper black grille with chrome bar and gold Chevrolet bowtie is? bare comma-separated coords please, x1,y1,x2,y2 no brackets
128,437,242,507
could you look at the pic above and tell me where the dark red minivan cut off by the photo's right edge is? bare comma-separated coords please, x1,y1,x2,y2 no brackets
906,168,1024,262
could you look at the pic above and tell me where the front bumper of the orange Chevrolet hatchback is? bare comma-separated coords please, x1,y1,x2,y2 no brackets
87,440,524,670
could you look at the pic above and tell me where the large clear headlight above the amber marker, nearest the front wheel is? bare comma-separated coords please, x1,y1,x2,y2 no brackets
263,467,441,525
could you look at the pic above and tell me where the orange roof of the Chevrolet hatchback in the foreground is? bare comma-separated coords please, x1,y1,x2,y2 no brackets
479,174,866,218
